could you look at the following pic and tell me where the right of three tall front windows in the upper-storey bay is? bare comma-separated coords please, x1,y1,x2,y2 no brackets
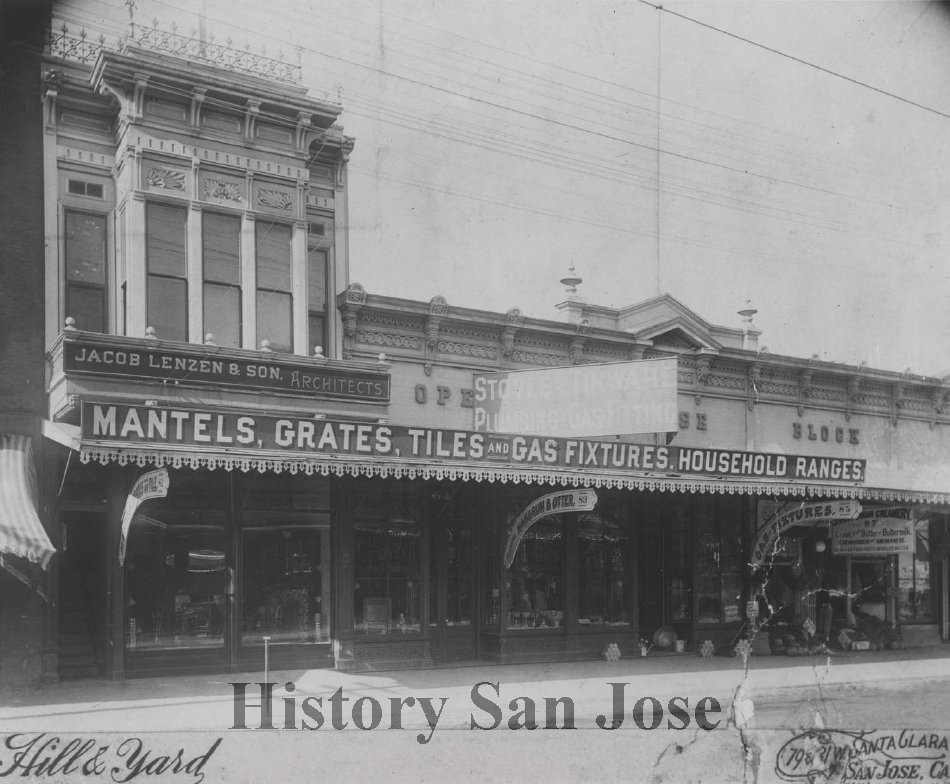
254,220,293,351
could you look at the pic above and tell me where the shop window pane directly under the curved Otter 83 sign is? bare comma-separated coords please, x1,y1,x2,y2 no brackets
508,518,564,629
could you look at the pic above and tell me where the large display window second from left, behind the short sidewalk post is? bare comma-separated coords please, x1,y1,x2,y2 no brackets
241,528,330,645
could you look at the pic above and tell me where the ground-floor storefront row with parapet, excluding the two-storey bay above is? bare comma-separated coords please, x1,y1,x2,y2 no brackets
42,284,948,677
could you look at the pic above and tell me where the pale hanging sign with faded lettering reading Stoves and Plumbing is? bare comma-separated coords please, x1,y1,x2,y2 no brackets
474,357,679,437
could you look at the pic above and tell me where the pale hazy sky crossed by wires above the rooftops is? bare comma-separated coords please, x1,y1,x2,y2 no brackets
54,0,950,376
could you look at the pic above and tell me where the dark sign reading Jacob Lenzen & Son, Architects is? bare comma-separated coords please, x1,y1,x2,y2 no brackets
63,337,390,403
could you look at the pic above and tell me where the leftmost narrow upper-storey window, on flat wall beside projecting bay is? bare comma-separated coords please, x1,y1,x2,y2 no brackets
64,210,108,332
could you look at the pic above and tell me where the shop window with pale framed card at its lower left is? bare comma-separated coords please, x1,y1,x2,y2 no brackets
353,483,422,634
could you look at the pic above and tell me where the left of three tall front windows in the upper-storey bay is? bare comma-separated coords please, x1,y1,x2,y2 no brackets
145,202,188,340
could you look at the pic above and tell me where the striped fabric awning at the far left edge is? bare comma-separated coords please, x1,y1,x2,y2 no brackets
0,434,56,569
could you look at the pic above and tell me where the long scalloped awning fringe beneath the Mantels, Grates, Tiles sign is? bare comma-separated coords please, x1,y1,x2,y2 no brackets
79,440,950,504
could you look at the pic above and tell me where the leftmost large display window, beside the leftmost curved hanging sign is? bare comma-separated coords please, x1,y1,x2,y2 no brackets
126,528,228,650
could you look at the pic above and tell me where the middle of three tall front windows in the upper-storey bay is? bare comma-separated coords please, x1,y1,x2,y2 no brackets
201,212,243,347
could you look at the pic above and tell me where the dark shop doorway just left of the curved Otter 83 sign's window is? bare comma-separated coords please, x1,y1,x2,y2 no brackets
429,521,479,664
